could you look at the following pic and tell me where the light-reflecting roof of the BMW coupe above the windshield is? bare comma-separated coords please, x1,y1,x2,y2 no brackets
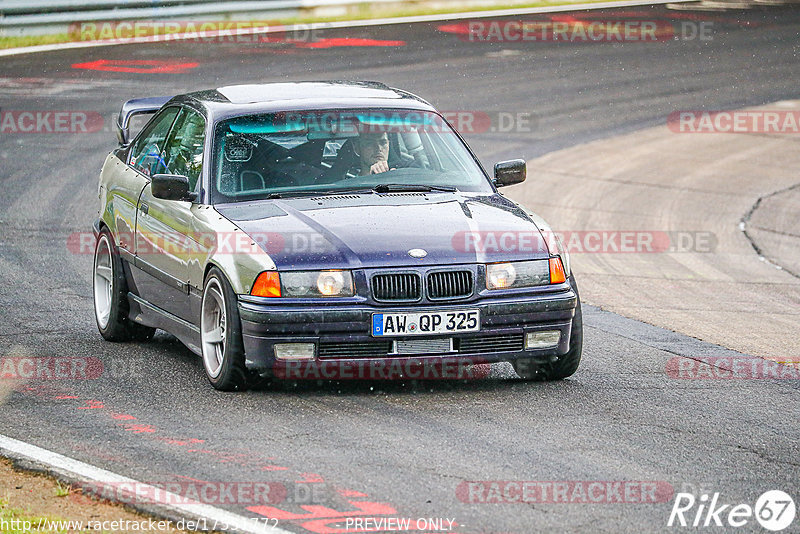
173,81,435,119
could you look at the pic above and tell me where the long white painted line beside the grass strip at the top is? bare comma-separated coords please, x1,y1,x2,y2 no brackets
0,0,699,57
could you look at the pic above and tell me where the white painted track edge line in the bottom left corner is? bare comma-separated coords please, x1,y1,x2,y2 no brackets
0,434,291,534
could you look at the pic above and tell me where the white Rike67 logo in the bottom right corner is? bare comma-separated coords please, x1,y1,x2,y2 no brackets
667,490,797,532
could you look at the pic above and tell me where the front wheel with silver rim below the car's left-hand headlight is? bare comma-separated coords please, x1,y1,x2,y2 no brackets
200,267,249,391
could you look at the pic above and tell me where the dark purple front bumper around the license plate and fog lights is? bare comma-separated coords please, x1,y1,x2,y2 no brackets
239,284,578,378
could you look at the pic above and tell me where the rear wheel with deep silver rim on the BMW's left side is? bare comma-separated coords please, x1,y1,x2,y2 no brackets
92,228,156,341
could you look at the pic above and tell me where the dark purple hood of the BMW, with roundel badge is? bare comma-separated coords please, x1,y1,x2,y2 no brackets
216,193,548,270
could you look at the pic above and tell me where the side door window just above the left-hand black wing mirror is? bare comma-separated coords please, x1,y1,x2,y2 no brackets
163,108,206,191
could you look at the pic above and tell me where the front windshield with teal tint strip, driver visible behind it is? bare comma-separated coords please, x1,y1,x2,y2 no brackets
212,110,492,203
